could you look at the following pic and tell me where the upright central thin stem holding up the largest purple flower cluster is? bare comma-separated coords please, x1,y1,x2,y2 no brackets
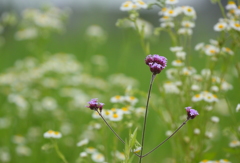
139,74,156,163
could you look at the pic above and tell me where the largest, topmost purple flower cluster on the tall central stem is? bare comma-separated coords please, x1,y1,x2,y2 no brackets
145,54,167,75
